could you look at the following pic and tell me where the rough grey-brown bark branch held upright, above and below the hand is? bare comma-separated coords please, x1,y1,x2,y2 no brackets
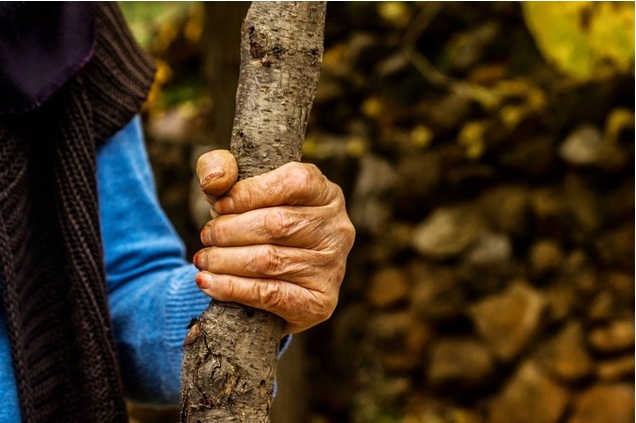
181,2,326,423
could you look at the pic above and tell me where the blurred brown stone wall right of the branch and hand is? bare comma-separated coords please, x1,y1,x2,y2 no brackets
305,3,634,423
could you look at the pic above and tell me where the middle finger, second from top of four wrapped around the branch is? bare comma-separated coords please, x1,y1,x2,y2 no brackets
201,206,339,249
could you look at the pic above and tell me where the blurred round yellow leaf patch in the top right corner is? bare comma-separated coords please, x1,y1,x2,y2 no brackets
522,1,634,81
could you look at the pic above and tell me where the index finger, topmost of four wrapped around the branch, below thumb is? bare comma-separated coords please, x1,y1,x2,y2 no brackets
214,162,339,214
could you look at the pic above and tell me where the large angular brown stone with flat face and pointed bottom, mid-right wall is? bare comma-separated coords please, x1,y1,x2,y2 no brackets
469,282,545,362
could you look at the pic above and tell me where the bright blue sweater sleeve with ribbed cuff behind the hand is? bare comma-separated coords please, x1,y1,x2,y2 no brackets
97,117,210,405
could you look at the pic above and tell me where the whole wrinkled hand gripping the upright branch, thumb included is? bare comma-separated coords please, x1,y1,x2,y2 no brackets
194,150,355,333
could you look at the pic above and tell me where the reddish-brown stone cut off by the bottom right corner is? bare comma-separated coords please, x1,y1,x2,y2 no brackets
568,384,634,423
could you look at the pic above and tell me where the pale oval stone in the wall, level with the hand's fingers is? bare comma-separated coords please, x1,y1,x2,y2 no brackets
411,206,484,259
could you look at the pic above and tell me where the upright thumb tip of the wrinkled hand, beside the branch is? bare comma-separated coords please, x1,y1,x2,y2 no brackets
196,150,238,201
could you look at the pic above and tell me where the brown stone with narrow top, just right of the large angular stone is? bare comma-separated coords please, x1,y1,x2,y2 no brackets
539,321,594,382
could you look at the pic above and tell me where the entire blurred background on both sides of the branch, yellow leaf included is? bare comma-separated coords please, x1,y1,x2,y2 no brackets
122,2,635,423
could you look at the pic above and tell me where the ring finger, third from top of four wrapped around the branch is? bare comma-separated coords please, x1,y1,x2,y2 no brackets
193,244,332,284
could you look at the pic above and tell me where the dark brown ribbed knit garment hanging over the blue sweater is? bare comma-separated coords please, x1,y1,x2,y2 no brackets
0,2,154,423
